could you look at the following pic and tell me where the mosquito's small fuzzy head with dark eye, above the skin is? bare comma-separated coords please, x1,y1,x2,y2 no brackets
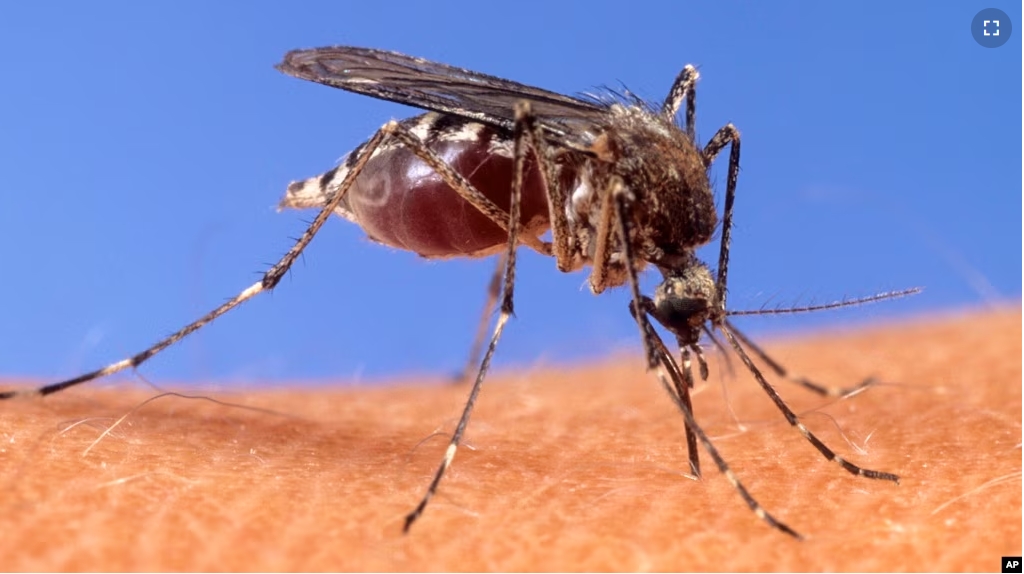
653,256,719,346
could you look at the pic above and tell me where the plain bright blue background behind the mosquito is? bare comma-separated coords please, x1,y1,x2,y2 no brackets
0,1,1022,383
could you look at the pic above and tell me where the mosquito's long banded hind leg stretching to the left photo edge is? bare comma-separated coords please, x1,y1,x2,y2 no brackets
0,122,398,400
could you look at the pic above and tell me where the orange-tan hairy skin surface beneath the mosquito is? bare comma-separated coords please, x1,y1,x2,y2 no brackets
0,308,1021,571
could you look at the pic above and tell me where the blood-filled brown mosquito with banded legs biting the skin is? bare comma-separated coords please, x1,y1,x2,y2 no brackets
6,46,918,538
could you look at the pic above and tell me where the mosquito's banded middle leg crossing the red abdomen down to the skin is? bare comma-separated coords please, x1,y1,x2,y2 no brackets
402,101,535,532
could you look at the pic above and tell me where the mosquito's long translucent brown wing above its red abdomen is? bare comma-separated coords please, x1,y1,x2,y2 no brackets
276,46,608,145
